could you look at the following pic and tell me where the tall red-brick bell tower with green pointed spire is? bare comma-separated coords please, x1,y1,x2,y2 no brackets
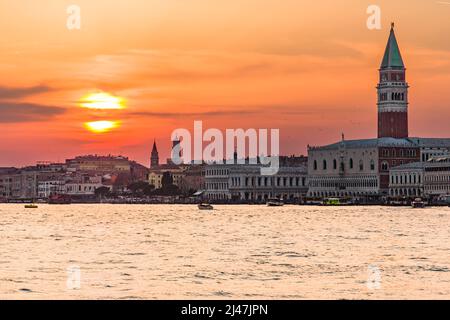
377,23,409,138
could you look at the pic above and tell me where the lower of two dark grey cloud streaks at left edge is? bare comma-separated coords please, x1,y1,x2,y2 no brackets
0,102,66,123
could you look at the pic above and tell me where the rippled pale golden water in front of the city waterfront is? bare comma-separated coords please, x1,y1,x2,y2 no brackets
0,204,450,299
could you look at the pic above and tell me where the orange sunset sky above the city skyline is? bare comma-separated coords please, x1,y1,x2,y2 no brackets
0,0,450,166
